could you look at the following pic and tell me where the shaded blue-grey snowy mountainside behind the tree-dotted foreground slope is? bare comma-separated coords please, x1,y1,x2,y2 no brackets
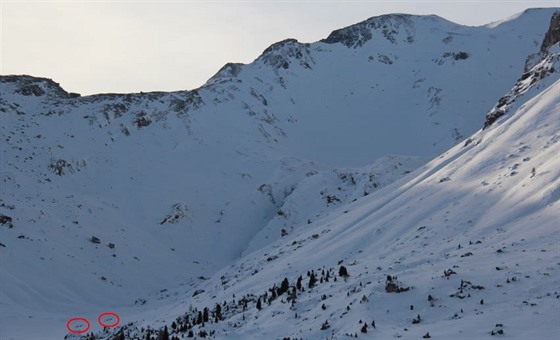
0,10,552,338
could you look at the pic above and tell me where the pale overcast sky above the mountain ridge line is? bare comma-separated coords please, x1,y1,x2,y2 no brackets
0,0,560,94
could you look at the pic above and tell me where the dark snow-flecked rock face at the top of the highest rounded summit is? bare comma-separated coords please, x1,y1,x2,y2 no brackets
321,14,414,48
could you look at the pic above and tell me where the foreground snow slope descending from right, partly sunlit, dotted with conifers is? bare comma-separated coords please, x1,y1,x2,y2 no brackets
94,29,560,339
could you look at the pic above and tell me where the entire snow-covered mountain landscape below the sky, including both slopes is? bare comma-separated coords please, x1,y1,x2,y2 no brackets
0,9,560,339
